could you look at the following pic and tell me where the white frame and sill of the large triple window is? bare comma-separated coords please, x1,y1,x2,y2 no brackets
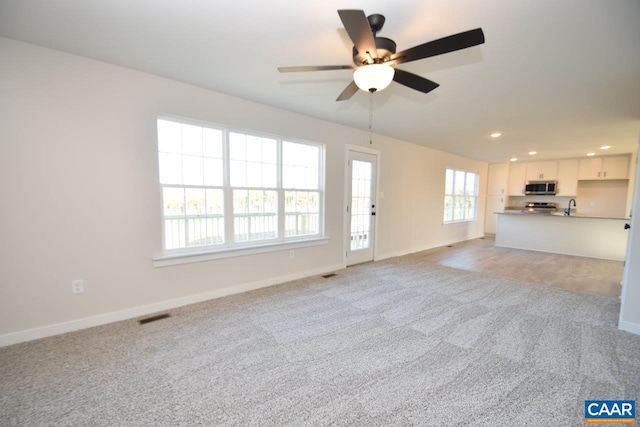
154,115,328,266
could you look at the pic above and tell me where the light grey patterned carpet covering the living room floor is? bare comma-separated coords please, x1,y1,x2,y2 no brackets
0,256,640,426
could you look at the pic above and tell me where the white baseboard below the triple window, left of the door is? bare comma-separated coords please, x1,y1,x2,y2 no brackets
0,264,346,347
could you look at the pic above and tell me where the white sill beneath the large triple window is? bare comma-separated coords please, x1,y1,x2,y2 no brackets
153,237,329,268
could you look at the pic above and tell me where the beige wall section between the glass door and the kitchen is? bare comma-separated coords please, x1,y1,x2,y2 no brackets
377,137,488,259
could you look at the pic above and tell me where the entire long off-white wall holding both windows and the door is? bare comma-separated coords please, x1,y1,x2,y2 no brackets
0,38,487,345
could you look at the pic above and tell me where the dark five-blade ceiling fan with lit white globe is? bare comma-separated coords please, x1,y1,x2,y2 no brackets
278,10,484,101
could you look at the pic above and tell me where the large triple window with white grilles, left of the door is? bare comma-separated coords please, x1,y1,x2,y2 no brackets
158,118,324,252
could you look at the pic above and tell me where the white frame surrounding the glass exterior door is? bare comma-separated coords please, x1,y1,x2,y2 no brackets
342,144,382,267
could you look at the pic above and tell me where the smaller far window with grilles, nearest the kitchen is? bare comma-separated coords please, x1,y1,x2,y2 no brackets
444,169,479,224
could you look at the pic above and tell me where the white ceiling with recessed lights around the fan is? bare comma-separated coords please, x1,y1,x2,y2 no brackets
0,0,640,162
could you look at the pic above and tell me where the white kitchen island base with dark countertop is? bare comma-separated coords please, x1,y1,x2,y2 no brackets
496,211,629,261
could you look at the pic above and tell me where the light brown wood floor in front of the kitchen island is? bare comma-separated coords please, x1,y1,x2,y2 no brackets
411,237,623,297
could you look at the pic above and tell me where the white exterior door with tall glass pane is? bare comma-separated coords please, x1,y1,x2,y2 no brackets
347,150,378,265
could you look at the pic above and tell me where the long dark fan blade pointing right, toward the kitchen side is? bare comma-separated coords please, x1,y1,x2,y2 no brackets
390,28,484,64
